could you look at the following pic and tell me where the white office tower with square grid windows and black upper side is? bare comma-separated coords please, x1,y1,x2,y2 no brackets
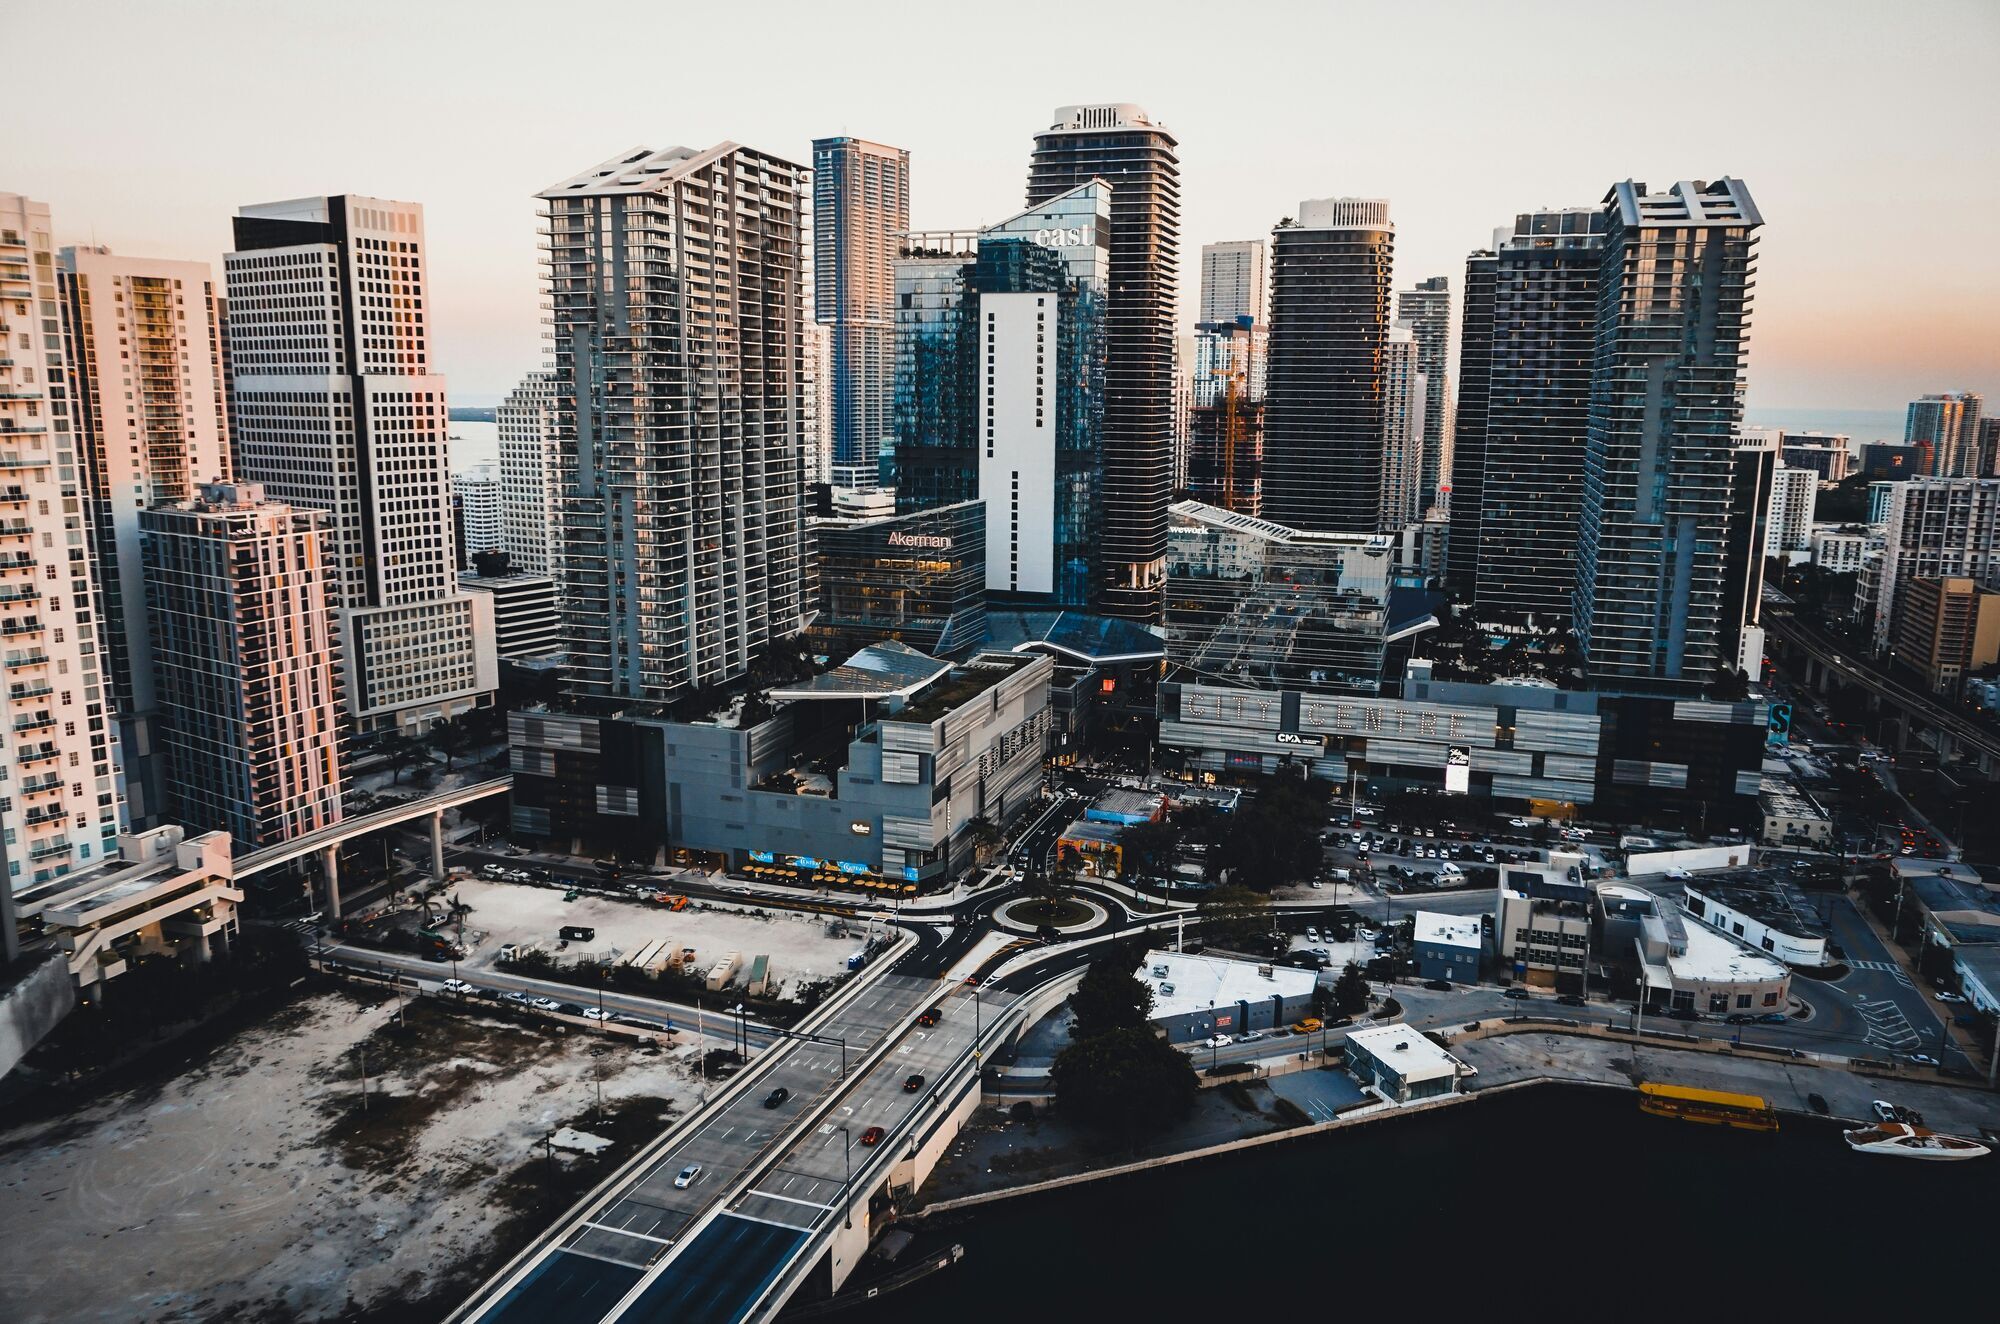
222,196,498,736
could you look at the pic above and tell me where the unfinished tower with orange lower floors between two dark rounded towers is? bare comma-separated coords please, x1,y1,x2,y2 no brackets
1184,316,1268,516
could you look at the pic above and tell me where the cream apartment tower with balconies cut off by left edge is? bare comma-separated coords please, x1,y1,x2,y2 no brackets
0,194,124,892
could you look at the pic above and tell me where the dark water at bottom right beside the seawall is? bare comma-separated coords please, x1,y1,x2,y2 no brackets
868,1086,2000,1324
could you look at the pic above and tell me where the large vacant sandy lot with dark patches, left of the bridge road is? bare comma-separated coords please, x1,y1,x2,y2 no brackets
0,992,694,1324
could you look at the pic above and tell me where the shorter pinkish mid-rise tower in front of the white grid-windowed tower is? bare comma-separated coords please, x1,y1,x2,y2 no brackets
140,482,342,850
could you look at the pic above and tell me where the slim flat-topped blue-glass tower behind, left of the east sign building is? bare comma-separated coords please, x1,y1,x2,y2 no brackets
812,138,910,488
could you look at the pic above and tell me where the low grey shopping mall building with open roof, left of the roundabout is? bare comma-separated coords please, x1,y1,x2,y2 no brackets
508,642,1054,890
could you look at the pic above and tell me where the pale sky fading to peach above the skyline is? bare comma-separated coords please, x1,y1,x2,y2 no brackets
0,0,2000,416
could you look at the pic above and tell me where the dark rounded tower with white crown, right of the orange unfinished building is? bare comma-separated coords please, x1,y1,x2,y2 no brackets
1264,198,1396,534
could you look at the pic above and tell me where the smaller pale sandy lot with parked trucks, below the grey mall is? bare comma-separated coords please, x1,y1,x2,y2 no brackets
452,880,880,996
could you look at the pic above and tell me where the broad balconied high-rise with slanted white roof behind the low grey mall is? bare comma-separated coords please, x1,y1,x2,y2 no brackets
540,142,806,704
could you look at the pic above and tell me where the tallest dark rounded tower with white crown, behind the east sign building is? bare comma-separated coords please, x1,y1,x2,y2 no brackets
1024,104,1180,622
